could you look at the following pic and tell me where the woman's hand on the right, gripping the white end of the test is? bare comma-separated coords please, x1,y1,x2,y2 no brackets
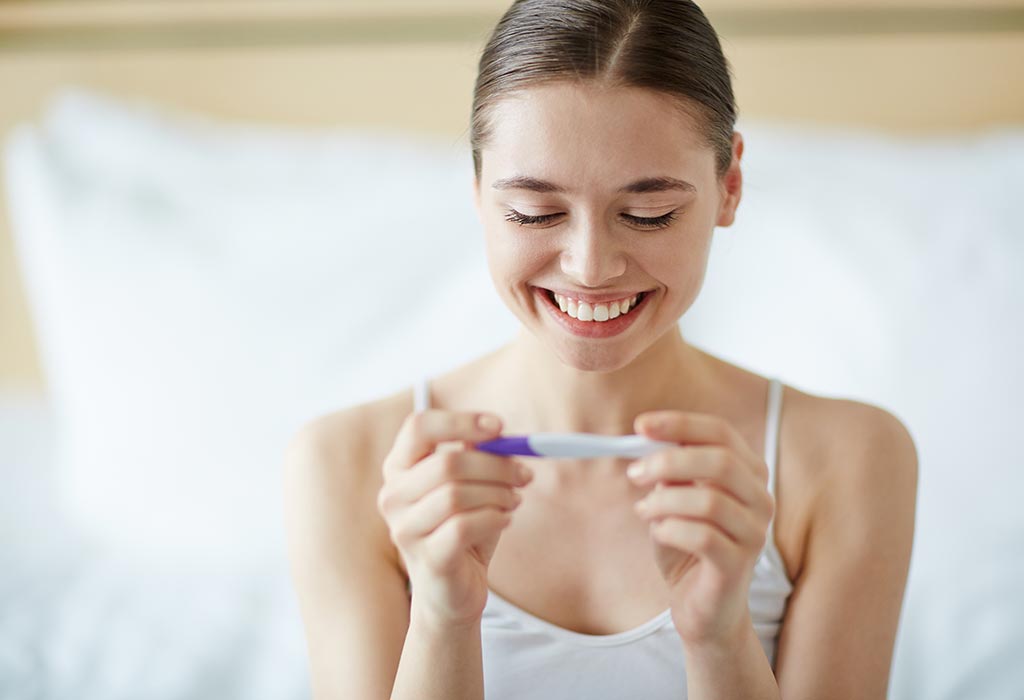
628,410,775,646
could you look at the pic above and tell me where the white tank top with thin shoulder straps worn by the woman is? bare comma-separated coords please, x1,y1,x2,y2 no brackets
414,379,793,700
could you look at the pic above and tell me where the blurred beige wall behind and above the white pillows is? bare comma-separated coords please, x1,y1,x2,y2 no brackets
6,0,1024,389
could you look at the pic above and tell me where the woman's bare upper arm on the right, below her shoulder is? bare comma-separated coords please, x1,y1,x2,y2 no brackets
776,401,918,700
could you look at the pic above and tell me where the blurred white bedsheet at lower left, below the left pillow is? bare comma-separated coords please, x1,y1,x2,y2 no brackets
0,393,309,700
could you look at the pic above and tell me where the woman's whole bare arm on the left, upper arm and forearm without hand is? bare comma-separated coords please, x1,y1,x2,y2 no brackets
285,408,491,700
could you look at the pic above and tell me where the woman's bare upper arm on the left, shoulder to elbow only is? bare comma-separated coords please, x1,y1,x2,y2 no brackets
284,409,409,700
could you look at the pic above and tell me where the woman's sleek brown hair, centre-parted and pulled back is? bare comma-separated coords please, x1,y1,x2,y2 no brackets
469,0,736,180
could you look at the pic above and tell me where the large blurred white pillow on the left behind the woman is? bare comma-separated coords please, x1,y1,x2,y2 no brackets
7,92,515,562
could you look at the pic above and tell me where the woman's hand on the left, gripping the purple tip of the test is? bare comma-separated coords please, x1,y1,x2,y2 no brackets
377,408,532,624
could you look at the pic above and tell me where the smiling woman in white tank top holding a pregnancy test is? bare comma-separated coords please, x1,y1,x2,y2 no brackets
287,0,916,700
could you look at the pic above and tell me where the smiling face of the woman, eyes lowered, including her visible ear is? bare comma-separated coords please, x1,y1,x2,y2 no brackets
475,82,742,371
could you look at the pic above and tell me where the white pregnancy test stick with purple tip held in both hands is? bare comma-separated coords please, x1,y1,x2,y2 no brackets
476,433,678,457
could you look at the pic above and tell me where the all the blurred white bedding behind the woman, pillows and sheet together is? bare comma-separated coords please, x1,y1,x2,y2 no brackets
0,93,1024,700
